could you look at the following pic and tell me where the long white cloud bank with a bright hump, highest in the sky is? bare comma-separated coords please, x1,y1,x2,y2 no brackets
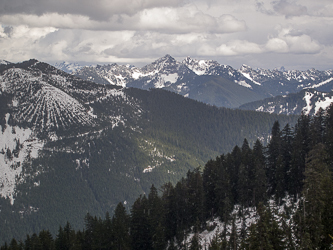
0,5,246,33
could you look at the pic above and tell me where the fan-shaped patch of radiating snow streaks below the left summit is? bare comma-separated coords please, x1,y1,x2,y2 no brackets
0,68,93,130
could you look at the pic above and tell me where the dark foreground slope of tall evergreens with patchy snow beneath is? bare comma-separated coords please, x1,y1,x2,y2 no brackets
2,105,333,250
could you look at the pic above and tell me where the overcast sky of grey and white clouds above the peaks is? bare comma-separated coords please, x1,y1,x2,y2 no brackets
0,0,333,70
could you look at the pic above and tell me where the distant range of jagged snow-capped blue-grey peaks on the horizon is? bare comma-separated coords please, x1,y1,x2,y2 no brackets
52,55,333,111
